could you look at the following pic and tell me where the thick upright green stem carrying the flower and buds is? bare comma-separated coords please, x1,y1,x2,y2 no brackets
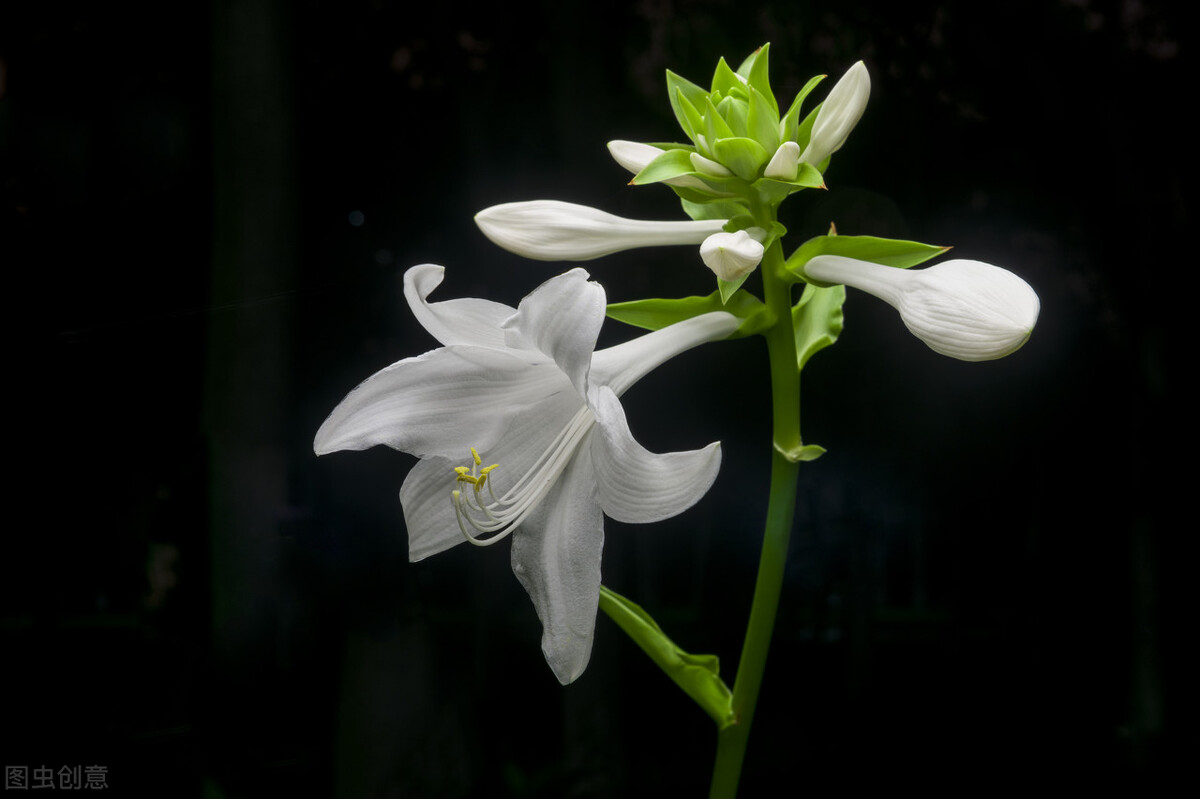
709,242,802,799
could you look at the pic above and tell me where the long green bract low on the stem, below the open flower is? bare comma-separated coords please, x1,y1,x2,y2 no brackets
600,585,734,729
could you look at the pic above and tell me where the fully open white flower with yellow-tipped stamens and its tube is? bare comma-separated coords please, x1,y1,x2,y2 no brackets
313,264,738,684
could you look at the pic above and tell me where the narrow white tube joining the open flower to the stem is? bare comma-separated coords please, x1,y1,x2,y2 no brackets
592,311,742,397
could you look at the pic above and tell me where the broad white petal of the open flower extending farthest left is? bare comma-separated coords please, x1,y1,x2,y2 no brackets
313,346,569,457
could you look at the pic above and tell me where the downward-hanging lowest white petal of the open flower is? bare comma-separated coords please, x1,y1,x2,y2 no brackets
511,441,604,685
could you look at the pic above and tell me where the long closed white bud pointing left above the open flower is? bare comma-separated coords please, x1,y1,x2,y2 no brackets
475,200,726,260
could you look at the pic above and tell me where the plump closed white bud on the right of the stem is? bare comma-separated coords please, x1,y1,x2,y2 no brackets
804,256,1040,361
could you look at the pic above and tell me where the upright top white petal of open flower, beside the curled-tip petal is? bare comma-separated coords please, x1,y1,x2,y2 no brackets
504,269,605,397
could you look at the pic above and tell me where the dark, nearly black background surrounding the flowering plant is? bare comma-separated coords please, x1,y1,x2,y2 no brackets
0,0,1200,798
